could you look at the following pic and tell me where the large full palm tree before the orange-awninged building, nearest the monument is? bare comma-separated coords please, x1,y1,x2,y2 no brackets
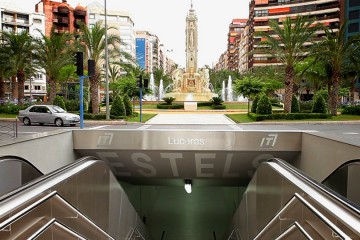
259,16,319,113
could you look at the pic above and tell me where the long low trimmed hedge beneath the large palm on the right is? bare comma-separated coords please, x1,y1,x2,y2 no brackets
249,113,332,121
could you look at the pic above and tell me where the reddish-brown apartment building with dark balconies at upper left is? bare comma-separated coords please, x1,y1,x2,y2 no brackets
35,0,87,36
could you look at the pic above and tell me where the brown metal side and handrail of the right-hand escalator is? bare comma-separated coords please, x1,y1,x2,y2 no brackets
224,159,360,240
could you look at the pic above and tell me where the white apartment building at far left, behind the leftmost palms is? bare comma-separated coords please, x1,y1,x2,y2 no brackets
0,4,46,100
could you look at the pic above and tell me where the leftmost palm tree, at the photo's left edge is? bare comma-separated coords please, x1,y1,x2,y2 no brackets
2,31,35,105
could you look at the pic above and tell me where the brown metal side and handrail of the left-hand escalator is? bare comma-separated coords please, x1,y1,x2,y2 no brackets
0,158,149,239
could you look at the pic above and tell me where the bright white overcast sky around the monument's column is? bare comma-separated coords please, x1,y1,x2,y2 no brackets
9,0,250,67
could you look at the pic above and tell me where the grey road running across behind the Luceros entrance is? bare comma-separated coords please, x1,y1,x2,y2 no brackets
0,116,360,145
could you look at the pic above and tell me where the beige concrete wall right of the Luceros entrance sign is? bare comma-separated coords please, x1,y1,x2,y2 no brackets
292,133,360,182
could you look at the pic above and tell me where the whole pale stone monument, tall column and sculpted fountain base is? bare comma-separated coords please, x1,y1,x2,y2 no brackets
165,2,217,101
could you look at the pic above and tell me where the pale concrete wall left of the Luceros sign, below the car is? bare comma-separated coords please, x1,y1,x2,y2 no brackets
0,130,79,174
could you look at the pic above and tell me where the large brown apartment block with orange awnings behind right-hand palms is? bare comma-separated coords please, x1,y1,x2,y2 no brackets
248,0,341,69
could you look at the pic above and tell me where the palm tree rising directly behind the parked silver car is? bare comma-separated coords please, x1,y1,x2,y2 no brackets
36,31,74,102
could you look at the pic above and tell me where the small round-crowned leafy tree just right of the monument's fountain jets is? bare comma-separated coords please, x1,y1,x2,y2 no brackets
234,77,264,114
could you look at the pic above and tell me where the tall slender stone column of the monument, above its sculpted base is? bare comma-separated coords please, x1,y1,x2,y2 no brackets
185,1,198,73
